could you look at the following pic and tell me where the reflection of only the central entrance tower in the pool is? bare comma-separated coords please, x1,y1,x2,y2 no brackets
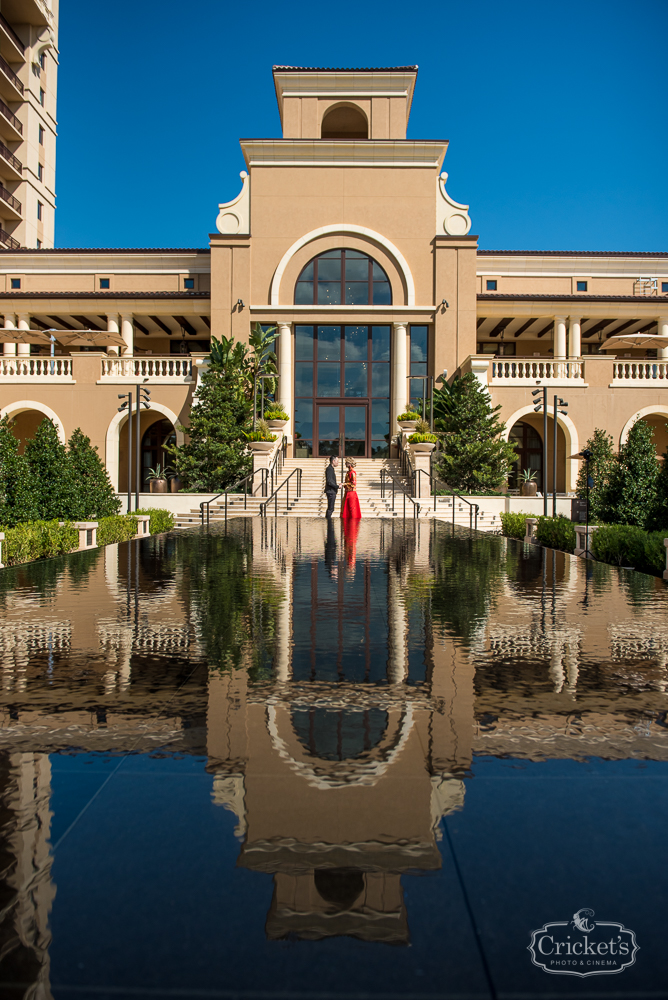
208,522,471,944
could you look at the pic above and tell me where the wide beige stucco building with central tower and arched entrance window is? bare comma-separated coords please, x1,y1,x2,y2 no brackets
0,64,668,491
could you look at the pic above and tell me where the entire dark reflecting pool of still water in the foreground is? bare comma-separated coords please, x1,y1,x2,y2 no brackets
0,519,668,1000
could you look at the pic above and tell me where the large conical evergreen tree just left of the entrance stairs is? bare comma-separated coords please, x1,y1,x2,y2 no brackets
170,337,253,492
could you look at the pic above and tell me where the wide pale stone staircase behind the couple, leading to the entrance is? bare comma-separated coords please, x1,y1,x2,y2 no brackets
175,458,499,531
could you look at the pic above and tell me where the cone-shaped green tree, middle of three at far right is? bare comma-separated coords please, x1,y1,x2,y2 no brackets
600,420,659,528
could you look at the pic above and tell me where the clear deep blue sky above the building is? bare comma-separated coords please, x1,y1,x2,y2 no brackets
56,0,668,251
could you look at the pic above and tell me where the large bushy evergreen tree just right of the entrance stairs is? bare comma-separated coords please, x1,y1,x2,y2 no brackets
437,372,517,492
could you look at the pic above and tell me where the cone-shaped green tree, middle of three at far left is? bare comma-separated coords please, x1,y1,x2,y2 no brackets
25,418,76,521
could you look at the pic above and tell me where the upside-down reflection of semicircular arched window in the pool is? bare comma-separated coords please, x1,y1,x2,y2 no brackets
292,707,388,760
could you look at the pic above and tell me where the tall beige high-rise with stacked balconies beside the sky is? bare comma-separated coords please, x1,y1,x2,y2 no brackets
0,0,58,250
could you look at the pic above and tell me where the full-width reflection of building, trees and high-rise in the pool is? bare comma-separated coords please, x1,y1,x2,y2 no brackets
0,519,668,988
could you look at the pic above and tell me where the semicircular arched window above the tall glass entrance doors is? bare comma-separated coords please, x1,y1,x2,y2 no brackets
295,250,392,306
